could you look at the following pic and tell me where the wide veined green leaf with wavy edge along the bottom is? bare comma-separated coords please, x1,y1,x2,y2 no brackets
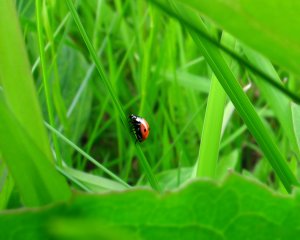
0,174,300,240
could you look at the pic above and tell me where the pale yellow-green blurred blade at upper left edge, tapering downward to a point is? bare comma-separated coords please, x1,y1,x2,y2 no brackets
0,0,53,162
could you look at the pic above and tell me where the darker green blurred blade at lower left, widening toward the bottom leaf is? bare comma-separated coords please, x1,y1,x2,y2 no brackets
0,93,71,206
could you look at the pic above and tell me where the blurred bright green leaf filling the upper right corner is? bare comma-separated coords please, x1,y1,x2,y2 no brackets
176,0,300,74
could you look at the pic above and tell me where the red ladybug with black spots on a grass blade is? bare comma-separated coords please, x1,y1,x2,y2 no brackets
129,114,150,142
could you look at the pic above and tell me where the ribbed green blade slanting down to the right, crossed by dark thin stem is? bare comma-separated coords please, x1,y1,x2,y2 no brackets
155,2,299,192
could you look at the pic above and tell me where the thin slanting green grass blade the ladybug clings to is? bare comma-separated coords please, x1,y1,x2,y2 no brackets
66,0,159,190
